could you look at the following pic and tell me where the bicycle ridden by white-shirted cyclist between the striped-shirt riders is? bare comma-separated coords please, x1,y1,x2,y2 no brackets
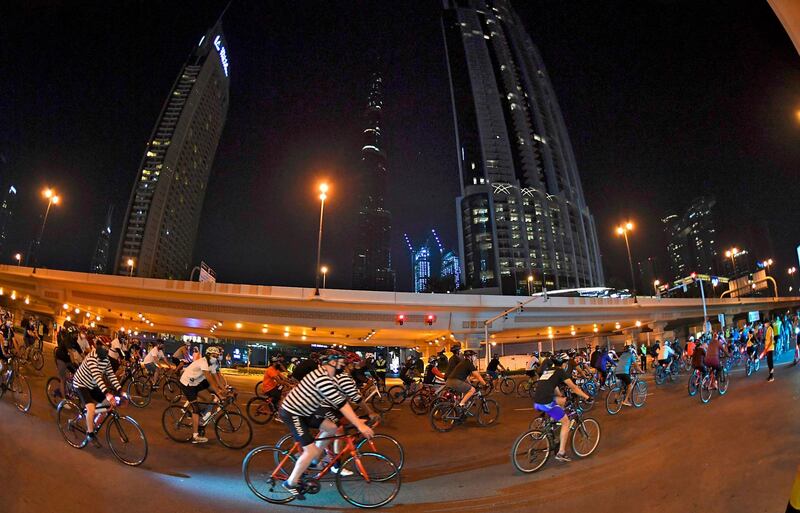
161,387,253,449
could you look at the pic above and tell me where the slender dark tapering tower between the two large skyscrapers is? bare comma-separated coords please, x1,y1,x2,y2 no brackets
353,73,394,290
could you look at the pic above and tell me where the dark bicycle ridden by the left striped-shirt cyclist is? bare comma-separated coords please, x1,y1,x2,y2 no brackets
56,398,148,467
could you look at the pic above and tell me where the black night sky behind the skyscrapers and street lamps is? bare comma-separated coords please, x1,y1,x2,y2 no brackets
0,0,800,290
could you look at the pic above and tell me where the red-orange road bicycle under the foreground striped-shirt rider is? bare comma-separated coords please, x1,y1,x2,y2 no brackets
242,424,401,508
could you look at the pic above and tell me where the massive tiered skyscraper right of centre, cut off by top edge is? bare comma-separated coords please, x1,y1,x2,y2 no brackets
442,0,603,294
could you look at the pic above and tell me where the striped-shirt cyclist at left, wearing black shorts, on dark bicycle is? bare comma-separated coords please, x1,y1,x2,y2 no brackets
72,340,126,447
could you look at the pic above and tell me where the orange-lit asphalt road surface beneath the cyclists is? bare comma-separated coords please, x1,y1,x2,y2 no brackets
0,352,800,513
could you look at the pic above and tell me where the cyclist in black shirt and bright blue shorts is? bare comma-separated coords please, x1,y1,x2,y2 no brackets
533,353,589,462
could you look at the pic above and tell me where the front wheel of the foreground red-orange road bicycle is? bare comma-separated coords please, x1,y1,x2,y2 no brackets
336,452,401,508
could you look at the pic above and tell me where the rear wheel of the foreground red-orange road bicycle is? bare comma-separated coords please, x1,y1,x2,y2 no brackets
242,445,295,504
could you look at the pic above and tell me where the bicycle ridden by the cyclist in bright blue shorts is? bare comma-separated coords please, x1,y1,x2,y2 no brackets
511,400,600,474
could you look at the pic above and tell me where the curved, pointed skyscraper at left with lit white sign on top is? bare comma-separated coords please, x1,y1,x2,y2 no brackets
116,21,230,279
